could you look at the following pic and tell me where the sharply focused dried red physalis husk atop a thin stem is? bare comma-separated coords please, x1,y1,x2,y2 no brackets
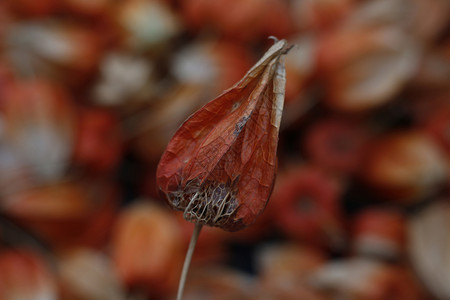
157,40,288,231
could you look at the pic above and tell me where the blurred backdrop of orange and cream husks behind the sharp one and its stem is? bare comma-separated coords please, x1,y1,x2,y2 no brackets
0,0,450,300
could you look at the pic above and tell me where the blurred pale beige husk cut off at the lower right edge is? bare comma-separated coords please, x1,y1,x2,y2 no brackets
409,202,450,300
